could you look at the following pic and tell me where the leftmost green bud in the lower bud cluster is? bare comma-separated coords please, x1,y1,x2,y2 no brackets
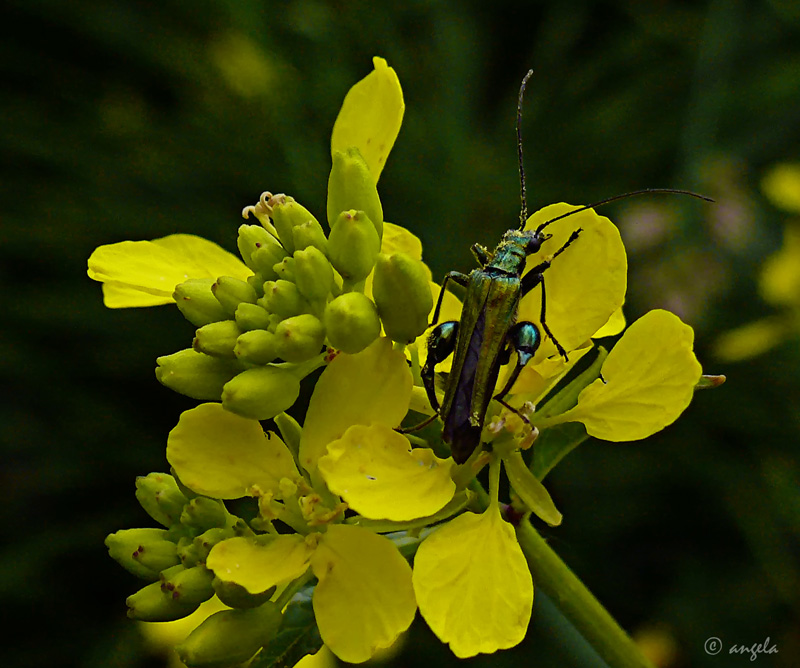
105,529,180,580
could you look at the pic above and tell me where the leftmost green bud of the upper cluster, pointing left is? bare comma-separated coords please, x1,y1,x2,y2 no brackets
156,348,241,401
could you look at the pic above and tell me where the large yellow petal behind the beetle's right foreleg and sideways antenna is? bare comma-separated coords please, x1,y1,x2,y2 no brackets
517,203,628,362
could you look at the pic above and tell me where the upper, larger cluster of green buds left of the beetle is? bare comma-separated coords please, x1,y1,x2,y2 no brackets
156,148,433,420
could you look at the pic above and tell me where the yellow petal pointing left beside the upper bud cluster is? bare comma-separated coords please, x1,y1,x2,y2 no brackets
87,234,253,308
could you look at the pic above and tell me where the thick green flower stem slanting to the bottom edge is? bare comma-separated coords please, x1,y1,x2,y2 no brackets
517,520,653,668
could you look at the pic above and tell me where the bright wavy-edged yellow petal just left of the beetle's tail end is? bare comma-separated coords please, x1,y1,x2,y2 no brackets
319,424,456,522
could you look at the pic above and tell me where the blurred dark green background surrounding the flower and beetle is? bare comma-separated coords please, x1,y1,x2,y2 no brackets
0,0,800,668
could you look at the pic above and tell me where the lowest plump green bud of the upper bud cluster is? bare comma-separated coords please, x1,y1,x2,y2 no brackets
222,366,300,420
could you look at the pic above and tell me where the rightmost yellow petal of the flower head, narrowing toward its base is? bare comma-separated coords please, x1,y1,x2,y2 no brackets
554,310,702,441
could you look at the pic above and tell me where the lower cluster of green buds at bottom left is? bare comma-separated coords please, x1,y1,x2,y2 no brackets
106,473,281,666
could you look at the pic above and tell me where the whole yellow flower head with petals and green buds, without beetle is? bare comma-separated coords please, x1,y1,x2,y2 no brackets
94,58,712,666
